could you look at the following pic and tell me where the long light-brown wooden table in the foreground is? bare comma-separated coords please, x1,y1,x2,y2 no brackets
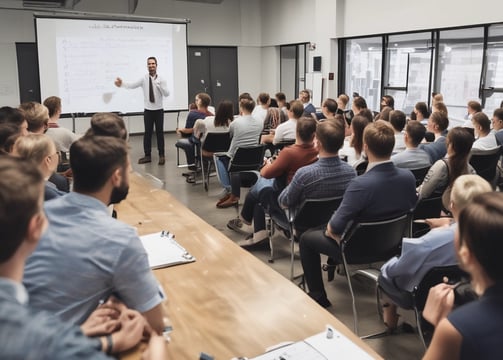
117,173,381,360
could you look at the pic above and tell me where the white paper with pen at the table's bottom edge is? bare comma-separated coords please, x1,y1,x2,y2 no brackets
250,326,372,360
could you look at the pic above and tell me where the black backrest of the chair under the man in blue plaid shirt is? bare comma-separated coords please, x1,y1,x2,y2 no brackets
293,196,342,232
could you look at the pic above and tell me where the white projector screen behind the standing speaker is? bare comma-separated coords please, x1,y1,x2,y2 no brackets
35,17,188,113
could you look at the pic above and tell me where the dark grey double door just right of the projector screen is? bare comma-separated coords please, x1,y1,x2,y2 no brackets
188,46,239,113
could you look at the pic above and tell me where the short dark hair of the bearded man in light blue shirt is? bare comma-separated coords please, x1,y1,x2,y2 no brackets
70,136,128,193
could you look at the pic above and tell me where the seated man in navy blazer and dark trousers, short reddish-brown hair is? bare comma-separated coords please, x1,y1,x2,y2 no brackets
300,120,417,307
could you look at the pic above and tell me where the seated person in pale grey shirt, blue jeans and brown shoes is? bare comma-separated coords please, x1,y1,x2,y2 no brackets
215,98,264,208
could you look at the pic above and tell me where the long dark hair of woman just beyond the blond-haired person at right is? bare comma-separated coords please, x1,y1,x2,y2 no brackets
447,127,474,186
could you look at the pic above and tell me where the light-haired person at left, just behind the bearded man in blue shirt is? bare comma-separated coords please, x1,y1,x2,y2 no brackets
12,134,65,201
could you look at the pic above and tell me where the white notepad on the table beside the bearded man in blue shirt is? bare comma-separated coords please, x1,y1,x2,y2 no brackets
140,231,196,269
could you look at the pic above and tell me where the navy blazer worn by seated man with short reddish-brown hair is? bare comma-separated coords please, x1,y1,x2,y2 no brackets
330,162,417,235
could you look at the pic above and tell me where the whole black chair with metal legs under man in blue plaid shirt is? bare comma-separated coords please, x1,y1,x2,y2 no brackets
269,196,342,280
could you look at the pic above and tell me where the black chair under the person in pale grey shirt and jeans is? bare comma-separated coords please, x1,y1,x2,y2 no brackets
227,144,265,217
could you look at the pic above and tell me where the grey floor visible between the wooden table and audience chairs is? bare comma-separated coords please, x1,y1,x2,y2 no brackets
129,134,424,360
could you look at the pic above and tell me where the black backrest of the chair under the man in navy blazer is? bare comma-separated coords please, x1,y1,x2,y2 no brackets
341,213,411,264
